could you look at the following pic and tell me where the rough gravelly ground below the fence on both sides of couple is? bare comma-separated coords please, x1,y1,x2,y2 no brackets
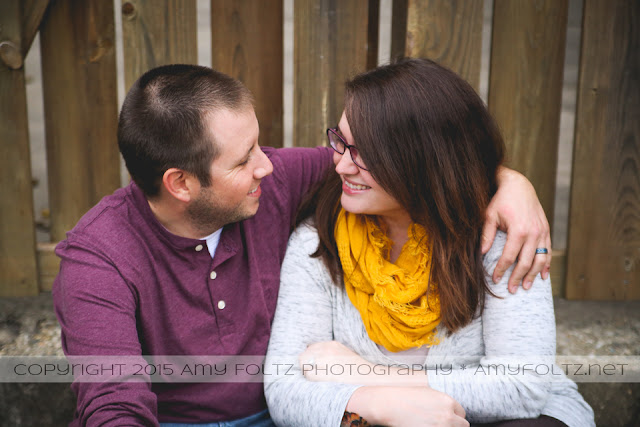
0,293,640,427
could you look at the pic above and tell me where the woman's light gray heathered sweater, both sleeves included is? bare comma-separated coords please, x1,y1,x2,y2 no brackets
265,224,595,427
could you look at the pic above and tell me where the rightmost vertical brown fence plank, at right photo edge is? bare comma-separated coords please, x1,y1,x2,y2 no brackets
567,0,640,300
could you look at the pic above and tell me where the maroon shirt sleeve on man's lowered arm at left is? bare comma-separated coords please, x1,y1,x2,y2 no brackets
53,240,158,426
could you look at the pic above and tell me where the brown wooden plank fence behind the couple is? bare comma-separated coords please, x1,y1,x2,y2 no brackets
0,0,640,300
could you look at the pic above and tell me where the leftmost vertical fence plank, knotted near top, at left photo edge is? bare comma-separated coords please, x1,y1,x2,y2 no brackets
0,0,38,297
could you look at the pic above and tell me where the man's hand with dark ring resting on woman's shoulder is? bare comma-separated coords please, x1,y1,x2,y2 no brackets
482,167,551,293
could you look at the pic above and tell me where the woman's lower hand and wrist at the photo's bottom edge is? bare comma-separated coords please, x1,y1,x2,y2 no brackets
346,386,469,427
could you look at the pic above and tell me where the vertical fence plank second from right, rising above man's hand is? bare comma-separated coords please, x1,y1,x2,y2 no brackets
489,0,569,232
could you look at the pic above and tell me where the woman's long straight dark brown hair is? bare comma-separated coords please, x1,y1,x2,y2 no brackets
298,59,504,332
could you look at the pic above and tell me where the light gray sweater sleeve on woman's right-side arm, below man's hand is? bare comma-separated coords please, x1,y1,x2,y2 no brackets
429,232,556,422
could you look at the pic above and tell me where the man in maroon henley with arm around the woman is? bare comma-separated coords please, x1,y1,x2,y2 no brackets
53,65,550,425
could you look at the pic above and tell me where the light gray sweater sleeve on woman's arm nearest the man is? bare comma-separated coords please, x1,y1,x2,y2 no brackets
265,224,358,426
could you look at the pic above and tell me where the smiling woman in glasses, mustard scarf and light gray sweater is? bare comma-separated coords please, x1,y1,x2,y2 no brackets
265,59,593,427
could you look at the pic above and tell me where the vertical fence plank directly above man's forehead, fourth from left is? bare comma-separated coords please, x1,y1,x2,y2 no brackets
211,0,283,147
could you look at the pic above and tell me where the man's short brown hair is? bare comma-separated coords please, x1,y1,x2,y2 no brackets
118,64,253,198
